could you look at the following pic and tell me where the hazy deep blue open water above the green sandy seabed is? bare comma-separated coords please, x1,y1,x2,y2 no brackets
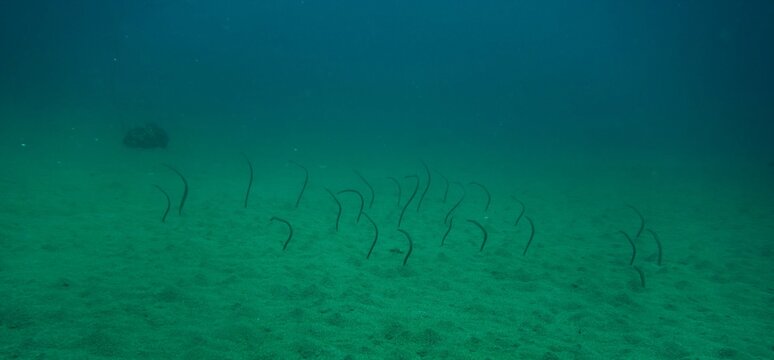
0,1,774,157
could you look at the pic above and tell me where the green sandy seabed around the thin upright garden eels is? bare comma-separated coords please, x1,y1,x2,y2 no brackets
0,131,774,359
